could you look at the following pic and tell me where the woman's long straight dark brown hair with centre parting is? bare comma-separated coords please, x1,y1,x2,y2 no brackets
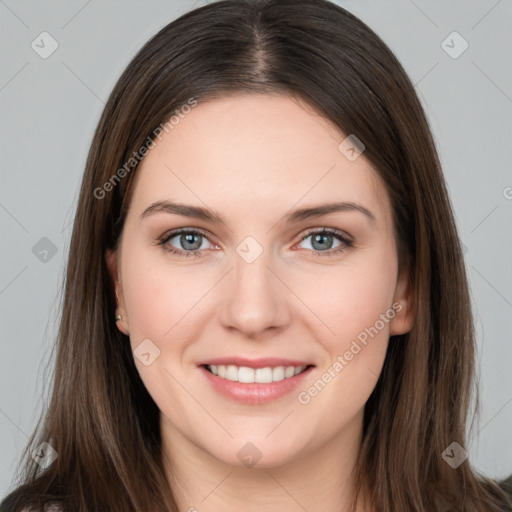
2,0,510,512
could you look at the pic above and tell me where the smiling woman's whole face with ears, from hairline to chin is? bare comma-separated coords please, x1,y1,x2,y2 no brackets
107,94,412,467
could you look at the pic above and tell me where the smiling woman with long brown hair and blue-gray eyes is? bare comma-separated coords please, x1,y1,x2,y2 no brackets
1,0,511,512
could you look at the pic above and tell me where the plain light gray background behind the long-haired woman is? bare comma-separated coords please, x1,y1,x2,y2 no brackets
0,0,512,496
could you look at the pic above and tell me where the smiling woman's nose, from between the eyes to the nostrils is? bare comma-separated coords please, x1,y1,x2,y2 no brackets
220,246,291,338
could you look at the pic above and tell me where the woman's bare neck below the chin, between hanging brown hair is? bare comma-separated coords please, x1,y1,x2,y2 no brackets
160,411,363,512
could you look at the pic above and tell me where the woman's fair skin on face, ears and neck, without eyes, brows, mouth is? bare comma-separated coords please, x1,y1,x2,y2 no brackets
106,94,413,512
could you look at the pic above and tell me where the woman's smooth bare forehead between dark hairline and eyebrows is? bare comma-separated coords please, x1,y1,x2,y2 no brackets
126,94,390,227
